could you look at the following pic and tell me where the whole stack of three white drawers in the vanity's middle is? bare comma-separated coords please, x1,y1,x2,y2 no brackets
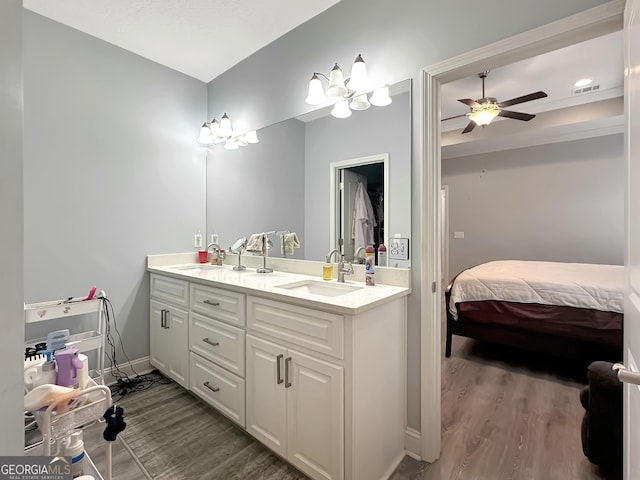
189,283,246,427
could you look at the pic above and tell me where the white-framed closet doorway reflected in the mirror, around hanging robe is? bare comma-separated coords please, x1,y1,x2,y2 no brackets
330,153,389,262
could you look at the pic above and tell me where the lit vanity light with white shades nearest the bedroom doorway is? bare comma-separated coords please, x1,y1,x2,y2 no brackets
306,54,391,118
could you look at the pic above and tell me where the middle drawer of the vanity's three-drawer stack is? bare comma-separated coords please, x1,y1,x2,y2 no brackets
189,313,244,377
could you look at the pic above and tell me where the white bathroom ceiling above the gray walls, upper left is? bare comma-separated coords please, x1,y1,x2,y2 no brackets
23,0,340,82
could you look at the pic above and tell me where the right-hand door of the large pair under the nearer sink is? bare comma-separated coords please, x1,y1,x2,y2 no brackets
285,350,344,480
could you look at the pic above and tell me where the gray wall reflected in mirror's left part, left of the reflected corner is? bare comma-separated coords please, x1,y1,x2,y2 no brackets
207,119,305,251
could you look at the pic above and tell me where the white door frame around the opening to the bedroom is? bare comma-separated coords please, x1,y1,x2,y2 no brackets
420,0,625,462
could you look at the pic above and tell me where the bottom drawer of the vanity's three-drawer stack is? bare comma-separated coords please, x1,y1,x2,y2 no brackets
189,352,245,428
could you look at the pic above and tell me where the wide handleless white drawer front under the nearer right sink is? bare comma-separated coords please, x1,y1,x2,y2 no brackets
247,296,345,359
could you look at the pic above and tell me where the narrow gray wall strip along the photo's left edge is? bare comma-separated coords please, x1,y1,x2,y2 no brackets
0,0,24,455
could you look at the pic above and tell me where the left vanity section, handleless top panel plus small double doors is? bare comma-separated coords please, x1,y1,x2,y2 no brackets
149,274,189,388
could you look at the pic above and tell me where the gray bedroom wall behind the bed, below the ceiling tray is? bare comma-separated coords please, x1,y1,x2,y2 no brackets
442,134,626,277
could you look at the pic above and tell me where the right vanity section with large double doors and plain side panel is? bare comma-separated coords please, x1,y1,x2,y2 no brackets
246,295,406,480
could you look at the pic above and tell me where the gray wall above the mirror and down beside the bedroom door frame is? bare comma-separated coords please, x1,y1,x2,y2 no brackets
206,0,606,430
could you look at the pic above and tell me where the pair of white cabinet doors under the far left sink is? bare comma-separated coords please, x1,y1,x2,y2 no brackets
149,300,189,389
